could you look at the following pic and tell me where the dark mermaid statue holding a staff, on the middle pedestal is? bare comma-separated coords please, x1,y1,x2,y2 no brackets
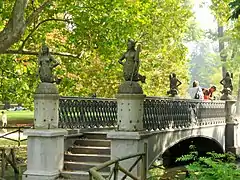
118,39,146,83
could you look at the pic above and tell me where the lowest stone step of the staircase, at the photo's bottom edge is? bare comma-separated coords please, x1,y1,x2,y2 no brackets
61,171,109,180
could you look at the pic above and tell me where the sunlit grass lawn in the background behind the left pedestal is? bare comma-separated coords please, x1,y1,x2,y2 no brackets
2,110,34,124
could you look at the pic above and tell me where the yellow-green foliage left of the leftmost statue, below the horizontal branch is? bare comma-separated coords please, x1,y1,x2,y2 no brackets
0,55,37,107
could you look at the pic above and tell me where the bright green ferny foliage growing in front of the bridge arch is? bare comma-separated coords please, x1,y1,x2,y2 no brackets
177,146,240,180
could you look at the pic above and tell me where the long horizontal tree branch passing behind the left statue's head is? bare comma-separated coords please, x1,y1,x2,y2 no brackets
3,49,84,59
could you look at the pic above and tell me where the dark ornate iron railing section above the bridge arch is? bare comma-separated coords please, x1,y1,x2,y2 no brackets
143,97,226,130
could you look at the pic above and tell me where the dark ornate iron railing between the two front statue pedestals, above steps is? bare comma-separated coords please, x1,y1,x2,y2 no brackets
59,97,117,128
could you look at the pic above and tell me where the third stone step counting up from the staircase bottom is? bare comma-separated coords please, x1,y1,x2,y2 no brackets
64,153,111,163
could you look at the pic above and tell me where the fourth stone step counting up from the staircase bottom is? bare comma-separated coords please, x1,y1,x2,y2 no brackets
69,146,111,154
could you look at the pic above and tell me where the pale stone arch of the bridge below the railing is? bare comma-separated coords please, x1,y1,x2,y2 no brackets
148,124,225,167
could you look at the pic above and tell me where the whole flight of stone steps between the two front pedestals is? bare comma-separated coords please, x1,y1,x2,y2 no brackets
61,132,111,180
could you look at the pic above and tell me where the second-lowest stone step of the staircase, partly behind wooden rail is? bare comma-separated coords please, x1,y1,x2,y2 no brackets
64,161,110,172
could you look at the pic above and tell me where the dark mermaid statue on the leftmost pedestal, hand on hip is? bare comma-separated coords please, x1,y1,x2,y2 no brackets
38,45,61,84
